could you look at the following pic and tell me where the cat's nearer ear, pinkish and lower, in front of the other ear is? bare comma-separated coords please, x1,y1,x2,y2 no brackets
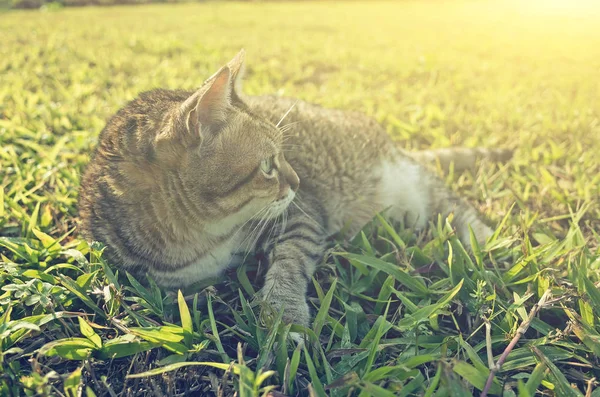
180,66,232,133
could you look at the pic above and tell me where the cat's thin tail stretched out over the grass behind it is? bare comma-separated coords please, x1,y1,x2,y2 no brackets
407,147,513,172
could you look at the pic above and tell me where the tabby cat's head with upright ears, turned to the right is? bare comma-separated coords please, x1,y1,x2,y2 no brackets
156,50,300,233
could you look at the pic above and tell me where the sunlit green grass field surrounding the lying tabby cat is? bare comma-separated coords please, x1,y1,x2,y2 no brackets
0,0,600,397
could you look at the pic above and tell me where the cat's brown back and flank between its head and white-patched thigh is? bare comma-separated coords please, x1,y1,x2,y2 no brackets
246,96,399,233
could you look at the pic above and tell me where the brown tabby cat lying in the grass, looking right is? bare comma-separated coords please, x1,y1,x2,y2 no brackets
79,50,510,326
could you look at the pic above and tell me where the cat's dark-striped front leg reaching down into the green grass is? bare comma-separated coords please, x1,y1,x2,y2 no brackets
261,205,326,326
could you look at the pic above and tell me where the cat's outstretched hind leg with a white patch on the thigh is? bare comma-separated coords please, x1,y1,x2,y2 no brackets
376,157,493,246
